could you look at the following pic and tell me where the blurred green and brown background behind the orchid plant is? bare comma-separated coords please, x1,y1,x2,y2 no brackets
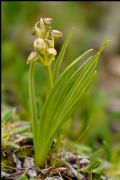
2,1,120,176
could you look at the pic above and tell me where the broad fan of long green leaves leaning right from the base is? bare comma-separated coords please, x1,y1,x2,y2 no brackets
31,41,108,165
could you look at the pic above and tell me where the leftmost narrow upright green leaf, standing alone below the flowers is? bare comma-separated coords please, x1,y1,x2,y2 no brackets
28,63,37,151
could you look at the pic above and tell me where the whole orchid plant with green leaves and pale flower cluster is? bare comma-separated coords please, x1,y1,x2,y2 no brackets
27,18,109,166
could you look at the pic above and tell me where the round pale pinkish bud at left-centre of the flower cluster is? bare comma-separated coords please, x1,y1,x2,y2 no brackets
34,38,46,50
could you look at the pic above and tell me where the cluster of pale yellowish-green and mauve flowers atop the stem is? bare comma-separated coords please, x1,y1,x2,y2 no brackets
27,18,63,66
